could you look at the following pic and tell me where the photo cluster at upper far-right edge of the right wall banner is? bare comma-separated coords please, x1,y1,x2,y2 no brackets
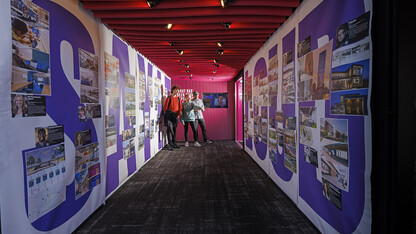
331,12,371,115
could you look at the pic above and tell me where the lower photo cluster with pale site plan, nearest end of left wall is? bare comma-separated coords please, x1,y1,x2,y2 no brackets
24,125,67,223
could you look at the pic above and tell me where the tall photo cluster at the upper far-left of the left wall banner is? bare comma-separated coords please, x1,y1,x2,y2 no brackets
10,0,48,118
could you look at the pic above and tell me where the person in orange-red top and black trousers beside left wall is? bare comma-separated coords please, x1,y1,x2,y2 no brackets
163,85,182,151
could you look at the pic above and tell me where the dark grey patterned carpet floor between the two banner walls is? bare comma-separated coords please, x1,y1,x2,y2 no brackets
75,141,319,234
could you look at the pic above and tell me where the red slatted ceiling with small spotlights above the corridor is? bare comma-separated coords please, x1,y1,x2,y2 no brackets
80,0,299,81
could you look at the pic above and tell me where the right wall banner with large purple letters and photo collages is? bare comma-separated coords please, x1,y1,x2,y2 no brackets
244,0,372,233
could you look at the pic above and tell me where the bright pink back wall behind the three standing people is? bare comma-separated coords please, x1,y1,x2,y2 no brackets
172,80,235,142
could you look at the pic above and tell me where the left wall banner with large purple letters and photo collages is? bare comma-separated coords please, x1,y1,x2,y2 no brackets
0,0,170,233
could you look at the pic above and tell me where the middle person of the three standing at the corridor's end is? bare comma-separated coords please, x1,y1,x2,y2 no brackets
181,93,201,147
